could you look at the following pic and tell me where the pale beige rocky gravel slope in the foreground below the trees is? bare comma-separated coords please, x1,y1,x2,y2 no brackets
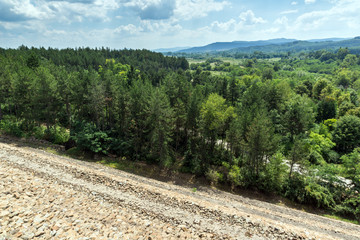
0,138,360,240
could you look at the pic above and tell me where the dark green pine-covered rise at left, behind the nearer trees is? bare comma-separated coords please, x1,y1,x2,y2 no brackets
0,46,189,73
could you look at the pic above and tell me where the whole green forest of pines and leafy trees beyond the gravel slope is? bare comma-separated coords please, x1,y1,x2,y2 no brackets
0,46,360,221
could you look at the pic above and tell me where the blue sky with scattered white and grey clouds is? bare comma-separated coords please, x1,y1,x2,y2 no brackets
0,0,360,49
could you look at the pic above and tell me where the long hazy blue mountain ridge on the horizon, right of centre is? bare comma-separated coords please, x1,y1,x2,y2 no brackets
178,38,296,53
